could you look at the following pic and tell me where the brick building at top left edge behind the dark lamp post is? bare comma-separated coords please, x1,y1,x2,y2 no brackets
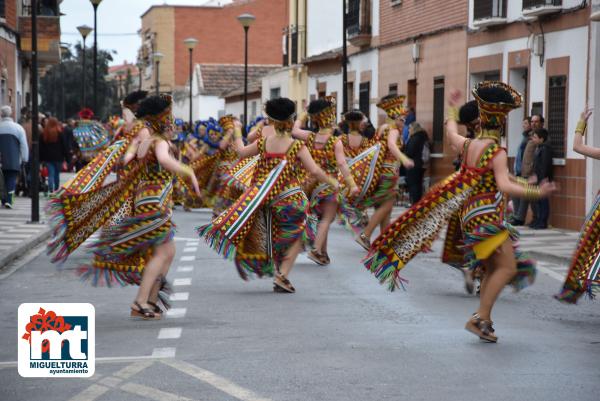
0,0,60,119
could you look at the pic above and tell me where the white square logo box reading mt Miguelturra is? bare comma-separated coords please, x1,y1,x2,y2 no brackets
18,302,96,377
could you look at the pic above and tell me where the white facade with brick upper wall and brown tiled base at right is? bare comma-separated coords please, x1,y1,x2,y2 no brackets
468,0,598,230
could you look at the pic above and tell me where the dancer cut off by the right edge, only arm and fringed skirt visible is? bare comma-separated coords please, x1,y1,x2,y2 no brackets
555,108,600,304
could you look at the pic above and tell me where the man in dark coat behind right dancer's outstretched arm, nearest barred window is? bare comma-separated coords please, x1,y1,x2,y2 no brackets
529,128,553,230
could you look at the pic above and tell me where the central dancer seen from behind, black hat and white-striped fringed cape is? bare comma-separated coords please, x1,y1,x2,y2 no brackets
198,98,337,293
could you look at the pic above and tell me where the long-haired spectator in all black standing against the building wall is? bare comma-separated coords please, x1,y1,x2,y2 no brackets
404,121,429,205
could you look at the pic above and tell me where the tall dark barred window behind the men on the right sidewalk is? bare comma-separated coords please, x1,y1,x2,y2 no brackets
548,75,567,158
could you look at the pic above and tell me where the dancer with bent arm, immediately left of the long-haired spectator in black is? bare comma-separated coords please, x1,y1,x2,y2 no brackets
356,95,414,250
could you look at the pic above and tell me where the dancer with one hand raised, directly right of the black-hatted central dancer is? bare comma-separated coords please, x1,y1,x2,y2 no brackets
292,98,359,266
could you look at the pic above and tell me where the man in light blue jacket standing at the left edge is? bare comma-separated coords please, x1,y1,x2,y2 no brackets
0,106,29,209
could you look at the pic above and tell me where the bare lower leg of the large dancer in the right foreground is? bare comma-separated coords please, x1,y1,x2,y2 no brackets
477,239,517,320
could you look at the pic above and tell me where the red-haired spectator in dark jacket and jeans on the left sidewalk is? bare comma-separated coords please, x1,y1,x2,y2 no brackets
40,117,67,192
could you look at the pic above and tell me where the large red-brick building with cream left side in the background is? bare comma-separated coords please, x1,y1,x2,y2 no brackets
139,0,288,118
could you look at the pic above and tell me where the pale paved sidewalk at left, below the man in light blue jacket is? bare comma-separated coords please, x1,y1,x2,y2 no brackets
0,193,50,270
